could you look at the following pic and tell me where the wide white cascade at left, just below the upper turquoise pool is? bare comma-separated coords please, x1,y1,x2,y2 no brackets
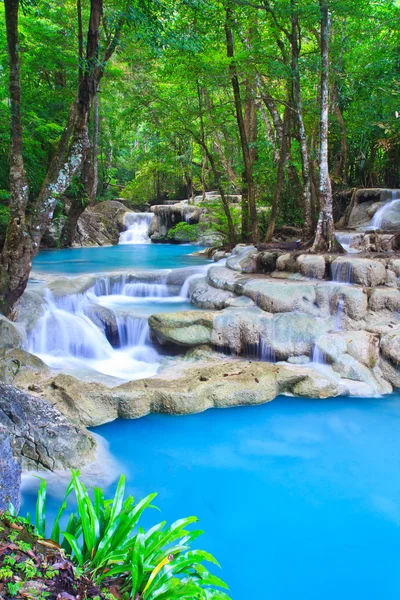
29,288,159,380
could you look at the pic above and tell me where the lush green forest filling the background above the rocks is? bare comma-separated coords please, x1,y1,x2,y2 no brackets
0,0,400,314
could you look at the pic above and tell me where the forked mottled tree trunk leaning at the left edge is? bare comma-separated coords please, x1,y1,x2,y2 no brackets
0,0,108,315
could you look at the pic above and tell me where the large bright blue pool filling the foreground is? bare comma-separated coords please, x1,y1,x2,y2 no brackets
25,394,400,600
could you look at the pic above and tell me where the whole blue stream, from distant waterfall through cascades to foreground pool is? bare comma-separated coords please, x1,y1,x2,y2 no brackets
22,218,400,600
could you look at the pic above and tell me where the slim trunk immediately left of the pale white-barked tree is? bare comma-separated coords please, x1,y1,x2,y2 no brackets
290,0,312,240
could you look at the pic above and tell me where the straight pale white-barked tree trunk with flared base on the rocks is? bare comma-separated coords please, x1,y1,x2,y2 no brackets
312,0,338,252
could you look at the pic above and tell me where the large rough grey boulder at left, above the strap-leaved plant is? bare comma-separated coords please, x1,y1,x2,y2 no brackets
0,383,96,471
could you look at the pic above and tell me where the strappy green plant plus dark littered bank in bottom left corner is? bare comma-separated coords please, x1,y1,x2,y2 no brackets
0,472,229,600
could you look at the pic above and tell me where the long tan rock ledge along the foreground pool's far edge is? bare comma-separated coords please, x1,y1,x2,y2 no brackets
113,360,338,419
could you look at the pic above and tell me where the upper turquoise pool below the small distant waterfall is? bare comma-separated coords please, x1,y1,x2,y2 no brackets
33,244,208,275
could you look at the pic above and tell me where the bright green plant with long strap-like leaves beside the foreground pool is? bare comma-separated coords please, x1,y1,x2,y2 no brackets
36,471,229,600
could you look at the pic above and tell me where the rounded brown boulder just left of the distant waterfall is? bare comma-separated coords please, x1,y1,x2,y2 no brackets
74,200,128,246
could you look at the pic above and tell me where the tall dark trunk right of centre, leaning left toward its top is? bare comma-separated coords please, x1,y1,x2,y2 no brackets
225,5,259,244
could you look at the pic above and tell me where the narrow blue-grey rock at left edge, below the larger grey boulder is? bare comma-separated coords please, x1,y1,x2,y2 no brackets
0,423,21,513
